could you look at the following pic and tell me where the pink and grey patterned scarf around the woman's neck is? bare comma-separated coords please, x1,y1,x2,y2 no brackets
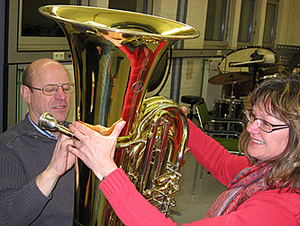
205,164,271,218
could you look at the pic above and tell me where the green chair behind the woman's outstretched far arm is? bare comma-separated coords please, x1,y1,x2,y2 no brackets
192,101,243,195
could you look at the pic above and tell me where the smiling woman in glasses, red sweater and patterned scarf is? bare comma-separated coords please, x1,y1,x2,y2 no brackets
69,75,300,226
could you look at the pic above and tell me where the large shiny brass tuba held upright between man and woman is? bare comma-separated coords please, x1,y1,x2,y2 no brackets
39,5,199,225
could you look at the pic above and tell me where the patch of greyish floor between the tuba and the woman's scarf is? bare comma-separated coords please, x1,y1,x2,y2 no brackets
171,152,226,225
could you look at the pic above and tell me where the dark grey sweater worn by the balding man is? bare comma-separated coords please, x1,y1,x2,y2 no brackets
0,115,74,226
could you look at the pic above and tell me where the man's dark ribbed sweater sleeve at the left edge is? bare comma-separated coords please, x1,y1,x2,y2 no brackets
0,147,50,226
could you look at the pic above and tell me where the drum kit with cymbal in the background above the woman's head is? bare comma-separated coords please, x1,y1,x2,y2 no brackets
208,47,283,123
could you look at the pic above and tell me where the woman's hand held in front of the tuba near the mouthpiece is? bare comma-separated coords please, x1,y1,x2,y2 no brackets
68,121,125,180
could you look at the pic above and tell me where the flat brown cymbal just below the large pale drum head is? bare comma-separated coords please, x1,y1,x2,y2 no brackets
208,72,252,85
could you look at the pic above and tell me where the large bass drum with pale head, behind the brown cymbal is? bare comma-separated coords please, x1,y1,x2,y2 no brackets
218,46,282,99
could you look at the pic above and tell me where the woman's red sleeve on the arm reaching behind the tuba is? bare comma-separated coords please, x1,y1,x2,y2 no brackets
187,120,251,186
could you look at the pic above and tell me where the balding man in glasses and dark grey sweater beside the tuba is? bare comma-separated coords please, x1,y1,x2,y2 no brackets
0,59,75,226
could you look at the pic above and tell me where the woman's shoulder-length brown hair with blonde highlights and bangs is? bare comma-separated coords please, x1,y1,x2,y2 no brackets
239,74,300,192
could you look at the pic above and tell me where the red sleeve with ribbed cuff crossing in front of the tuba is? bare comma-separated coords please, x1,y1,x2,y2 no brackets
99,168,177,226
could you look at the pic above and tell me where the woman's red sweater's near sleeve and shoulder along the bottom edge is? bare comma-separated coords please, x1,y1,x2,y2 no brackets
99,168,300,226
